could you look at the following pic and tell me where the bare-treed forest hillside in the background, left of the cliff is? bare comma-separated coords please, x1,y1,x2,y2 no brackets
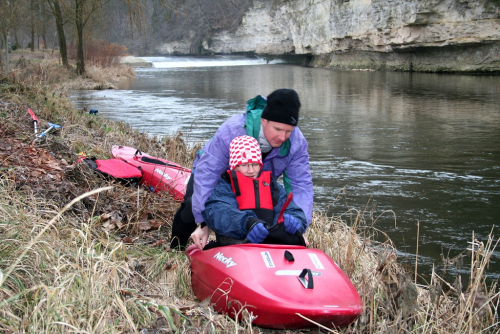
0,0,252,66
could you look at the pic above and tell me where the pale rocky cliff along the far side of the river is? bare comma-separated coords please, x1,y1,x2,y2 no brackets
158,0,500,72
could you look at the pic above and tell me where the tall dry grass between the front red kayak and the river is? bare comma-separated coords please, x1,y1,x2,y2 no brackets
307,211,500,333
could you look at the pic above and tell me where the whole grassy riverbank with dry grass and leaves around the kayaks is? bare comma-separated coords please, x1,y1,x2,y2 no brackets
0,53,498,333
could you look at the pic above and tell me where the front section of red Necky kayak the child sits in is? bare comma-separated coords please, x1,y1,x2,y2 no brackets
186,244,363,329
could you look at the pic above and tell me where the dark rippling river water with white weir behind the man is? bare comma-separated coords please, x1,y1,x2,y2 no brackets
71,57,500,279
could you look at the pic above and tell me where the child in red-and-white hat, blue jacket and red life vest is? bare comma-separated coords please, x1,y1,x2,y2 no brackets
194,135,307,245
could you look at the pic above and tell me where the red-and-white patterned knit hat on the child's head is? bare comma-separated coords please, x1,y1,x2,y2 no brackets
229,135,262,170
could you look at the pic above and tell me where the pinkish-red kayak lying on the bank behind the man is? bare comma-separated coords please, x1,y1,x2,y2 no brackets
111,145,191,201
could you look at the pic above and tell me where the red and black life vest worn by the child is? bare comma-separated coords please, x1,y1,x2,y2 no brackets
228,170,279,224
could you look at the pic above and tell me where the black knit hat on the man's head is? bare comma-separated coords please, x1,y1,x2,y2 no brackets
262,89,300,126
